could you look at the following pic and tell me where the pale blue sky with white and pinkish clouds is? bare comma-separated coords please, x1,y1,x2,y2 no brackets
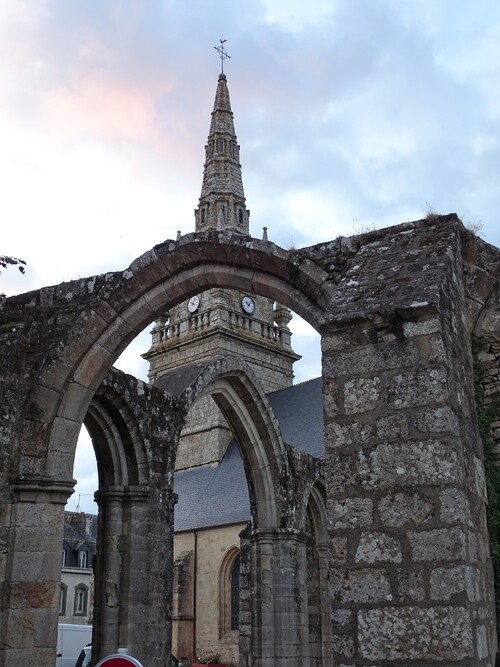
0,0,500,508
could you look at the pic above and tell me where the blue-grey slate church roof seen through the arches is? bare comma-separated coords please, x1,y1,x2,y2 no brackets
174,378,324,532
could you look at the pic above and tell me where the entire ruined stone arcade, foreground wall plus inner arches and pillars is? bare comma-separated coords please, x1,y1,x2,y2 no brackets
0,215,500,667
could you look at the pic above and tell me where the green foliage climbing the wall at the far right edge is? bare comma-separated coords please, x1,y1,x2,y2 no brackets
472,336,500,634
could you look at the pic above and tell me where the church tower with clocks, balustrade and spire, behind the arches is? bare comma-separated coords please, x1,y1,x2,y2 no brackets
142,65,300,469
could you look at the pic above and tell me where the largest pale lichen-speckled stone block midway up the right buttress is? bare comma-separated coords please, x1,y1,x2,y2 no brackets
359,440,462,489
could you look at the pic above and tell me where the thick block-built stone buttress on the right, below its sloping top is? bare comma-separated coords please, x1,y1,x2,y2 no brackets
322,310,494,667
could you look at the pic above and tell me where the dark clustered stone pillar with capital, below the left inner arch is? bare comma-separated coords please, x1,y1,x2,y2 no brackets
92,487,173,667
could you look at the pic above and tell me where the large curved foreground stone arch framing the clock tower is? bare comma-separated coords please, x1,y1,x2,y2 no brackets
23,232,332,476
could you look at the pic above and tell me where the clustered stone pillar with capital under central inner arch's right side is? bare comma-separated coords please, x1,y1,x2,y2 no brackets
251,530,309,667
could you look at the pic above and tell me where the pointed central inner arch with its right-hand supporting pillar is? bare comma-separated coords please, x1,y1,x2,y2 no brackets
155,355,316,665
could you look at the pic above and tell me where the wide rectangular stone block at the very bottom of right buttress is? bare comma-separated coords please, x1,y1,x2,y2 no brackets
358,606,473,664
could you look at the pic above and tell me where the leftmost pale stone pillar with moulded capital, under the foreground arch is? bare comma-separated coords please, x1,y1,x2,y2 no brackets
0,478,74,667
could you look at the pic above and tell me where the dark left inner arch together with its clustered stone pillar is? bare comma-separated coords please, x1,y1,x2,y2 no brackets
84,369,184,659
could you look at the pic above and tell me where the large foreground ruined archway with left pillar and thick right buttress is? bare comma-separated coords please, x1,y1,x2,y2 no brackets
0,215,500,667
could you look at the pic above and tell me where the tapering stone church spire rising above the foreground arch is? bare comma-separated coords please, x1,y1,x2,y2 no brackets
194,53,250,234
